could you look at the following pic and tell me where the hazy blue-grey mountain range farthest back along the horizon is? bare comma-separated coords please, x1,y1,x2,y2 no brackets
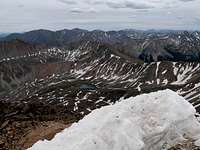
0,29,200,62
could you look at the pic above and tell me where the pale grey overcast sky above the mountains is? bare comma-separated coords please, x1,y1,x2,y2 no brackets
0,0,200,32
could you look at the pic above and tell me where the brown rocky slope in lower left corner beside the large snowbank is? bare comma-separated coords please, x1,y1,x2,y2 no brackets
0,101,79,150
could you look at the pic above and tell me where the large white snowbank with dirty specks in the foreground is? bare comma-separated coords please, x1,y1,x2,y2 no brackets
28,90,200,150
